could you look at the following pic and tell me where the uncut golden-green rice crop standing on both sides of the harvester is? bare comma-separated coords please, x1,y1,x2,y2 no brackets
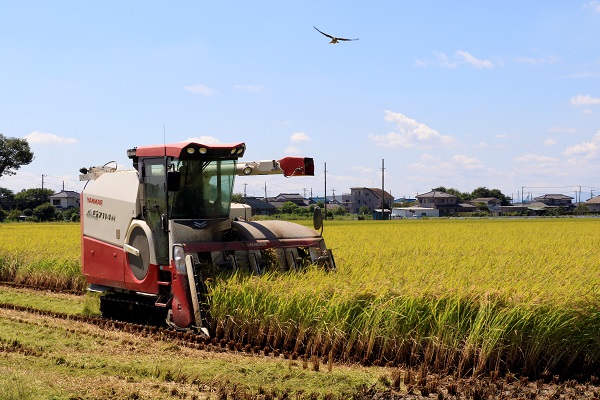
0,218,600,377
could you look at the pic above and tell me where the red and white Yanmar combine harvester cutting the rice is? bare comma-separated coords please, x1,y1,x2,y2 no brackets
80,142,335,334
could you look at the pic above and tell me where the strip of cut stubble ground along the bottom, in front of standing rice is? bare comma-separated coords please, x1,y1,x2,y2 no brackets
0,287,600,400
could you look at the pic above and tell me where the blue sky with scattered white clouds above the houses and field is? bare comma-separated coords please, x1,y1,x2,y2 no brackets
0,0,600,200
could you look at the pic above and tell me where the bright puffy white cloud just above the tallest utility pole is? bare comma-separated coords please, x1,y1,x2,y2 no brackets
369,110,454,147
